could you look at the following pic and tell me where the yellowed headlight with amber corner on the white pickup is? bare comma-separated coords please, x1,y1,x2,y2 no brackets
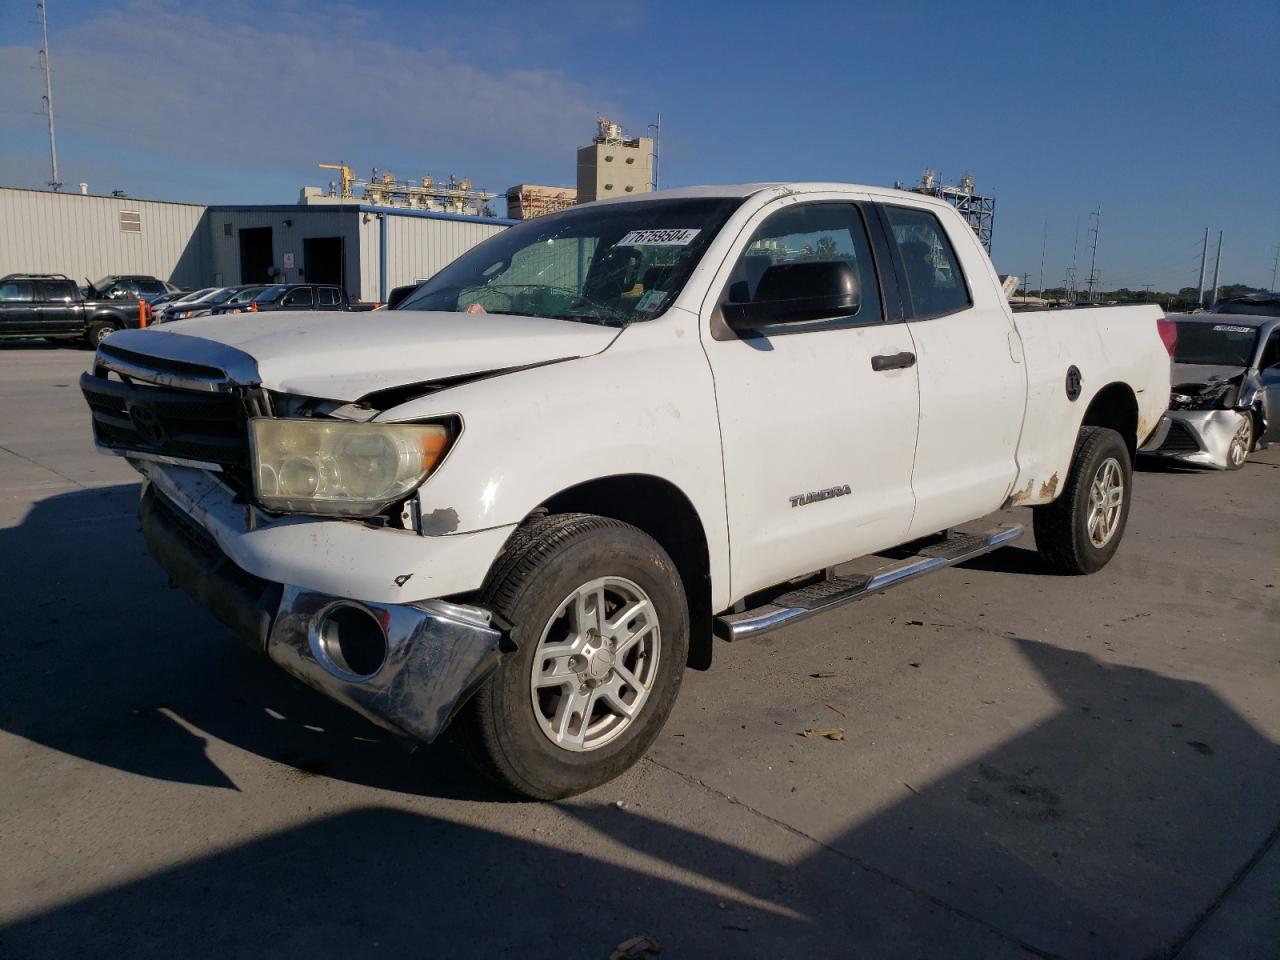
250,417,449,516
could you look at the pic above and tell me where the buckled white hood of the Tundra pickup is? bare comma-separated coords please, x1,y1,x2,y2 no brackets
132,310,618,401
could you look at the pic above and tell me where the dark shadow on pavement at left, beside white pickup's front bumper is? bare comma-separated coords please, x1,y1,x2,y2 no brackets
0,484,509,799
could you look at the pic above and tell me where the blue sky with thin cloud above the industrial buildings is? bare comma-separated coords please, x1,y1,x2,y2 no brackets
0,0,1280,289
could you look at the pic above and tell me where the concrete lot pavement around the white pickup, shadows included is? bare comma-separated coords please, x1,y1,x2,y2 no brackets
0,344,1280,960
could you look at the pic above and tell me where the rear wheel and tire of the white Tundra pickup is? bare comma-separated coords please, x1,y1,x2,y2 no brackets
1032,426,1133,575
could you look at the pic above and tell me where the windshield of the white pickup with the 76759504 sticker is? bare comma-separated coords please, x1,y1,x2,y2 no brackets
396,197,742,326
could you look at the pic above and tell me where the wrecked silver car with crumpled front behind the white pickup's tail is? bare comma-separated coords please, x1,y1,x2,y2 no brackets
1144,305,1280,470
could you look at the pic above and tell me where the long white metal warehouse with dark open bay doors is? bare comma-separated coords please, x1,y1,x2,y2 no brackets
0,187,515,301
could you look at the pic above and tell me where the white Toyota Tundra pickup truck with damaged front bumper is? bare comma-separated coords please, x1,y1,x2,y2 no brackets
81,183,1170,797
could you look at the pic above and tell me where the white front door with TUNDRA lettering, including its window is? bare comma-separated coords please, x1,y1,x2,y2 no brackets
703,195,919,598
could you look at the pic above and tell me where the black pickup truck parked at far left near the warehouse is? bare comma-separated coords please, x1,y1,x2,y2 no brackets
0,274,142,349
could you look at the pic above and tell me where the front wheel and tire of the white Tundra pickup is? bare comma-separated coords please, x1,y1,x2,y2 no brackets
458,513,689,800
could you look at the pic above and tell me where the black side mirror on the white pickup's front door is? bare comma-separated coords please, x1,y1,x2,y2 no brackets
721,260,861,332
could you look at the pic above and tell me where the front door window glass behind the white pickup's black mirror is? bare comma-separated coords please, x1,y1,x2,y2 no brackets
726,204,883,323
